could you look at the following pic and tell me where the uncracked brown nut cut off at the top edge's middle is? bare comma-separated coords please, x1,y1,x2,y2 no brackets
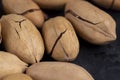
34,0,70,9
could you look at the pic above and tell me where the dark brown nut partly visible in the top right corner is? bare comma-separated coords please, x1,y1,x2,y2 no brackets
91,0,120,10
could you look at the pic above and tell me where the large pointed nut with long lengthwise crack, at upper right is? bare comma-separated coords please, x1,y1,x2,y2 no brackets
65,0,116,44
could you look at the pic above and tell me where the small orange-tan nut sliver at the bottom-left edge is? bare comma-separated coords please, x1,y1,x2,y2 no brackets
2,73,32,80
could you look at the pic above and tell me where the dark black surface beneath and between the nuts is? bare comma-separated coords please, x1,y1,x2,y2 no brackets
0,2,120,80
